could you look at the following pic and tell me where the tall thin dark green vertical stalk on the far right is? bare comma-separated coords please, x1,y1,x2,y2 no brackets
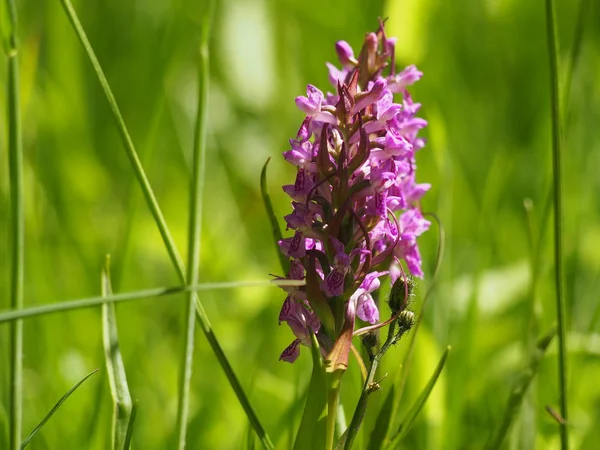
546,0,569,450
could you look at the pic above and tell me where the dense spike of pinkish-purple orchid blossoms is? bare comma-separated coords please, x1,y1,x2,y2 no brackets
279,23,430,369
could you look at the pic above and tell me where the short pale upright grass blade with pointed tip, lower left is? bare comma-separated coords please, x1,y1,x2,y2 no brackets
102,255,132,450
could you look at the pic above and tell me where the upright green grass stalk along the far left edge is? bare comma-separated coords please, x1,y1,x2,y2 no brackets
5,0,25,449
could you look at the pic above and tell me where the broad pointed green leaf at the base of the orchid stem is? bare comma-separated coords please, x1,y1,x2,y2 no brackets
294,334,327,450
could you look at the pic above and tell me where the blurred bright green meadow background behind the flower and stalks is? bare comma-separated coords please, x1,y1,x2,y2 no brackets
0,0,600,449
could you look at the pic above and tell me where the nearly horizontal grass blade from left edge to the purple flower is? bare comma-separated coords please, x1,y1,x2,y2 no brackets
0,280,303,323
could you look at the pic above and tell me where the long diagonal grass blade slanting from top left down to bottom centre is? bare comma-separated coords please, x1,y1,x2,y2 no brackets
61,0,273,448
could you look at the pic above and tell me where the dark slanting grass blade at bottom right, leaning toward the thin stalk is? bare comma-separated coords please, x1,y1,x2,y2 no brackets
486,328,556,450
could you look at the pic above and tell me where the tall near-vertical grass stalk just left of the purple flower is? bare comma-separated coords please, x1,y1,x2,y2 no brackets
177,0,215,444
